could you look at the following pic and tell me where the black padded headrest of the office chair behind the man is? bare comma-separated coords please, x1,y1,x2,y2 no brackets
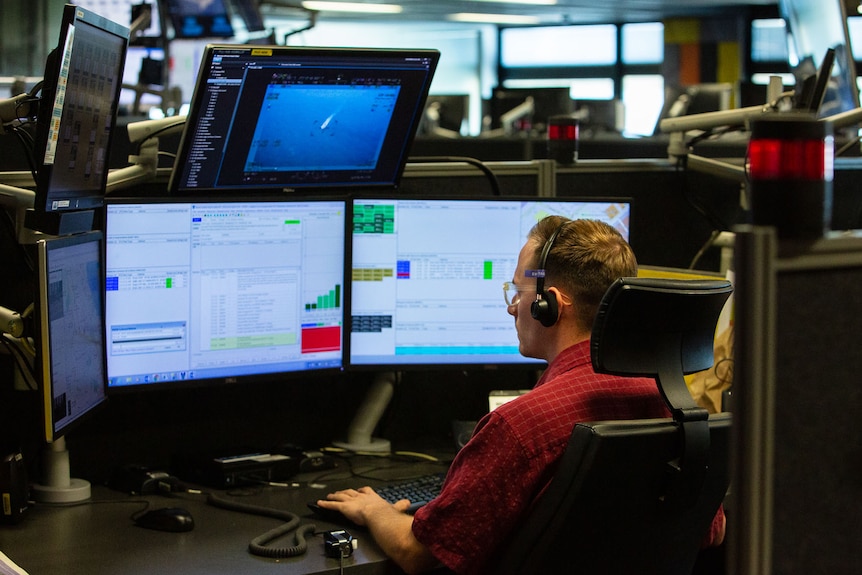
591,277,733,377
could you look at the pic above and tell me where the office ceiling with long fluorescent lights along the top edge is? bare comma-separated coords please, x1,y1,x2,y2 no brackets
262,0,778,24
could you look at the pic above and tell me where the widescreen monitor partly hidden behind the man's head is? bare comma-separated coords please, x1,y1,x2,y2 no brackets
349,196,631,369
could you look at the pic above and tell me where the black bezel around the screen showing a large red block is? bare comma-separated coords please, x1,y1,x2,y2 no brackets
101,194,350,397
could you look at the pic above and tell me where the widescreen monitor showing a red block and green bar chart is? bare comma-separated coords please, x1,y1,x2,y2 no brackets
105,197,347,393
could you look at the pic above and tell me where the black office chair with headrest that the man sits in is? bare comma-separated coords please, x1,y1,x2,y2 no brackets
494,278,732,575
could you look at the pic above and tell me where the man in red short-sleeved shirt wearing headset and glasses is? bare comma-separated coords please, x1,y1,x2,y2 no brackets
319,216,725,574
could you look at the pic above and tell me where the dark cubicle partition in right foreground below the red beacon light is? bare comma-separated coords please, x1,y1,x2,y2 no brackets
727,227,862,575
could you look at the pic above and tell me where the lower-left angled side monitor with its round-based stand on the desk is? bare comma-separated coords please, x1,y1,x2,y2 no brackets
33,231,107,502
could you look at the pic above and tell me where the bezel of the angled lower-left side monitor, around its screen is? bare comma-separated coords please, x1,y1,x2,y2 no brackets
34,230,109,443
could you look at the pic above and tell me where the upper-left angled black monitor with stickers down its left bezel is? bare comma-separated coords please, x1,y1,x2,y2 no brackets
25,4,129,235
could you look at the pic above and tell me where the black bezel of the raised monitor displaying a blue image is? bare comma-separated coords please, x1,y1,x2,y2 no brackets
168,43,440,196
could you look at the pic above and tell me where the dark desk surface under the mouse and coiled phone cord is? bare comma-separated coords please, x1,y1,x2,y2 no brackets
0,457,443,575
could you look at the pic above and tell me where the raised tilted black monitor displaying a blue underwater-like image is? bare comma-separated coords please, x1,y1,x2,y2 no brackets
169,45,440,195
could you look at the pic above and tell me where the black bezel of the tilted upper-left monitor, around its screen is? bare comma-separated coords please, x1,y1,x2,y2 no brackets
33,4,129,227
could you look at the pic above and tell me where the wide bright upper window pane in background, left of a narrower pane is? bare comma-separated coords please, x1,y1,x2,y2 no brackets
500,24,617,68
